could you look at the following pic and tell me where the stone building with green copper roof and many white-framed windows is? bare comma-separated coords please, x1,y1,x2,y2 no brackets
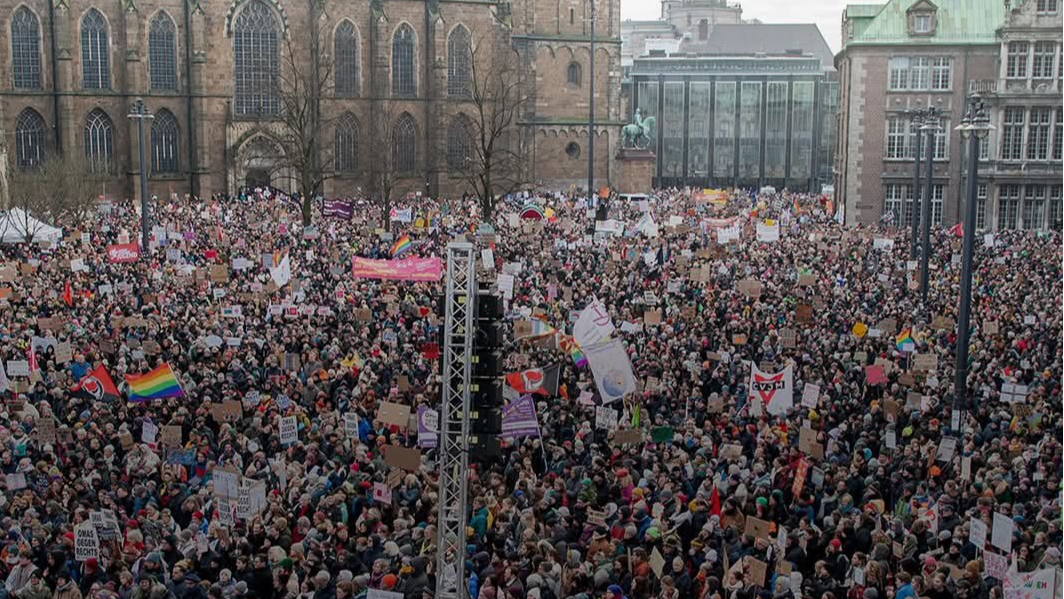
834,0,1064,229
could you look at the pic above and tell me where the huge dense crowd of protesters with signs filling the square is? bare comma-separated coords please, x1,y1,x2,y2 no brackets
0,189,1062,599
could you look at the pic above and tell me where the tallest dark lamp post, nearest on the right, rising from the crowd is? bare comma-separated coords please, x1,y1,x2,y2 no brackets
950,96,994,435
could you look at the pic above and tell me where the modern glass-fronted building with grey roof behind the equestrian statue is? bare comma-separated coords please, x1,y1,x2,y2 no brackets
629,24,837,192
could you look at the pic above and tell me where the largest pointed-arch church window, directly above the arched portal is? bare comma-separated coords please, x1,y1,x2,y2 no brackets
233,0,281,116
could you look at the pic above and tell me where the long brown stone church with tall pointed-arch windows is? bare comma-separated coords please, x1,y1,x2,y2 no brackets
0,0,622,197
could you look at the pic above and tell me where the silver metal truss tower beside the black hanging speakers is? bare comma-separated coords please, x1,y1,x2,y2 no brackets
436,242,477,599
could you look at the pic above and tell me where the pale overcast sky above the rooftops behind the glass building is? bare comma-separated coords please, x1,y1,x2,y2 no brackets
620,0,853,52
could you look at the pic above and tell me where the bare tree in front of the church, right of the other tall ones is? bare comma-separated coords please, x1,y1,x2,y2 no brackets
442,32,529,221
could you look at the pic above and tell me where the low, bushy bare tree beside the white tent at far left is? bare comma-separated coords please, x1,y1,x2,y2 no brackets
6,152,96,244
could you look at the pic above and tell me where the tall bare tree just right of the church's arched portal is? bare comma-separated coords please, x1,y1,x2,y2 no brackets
275,11,333,226
